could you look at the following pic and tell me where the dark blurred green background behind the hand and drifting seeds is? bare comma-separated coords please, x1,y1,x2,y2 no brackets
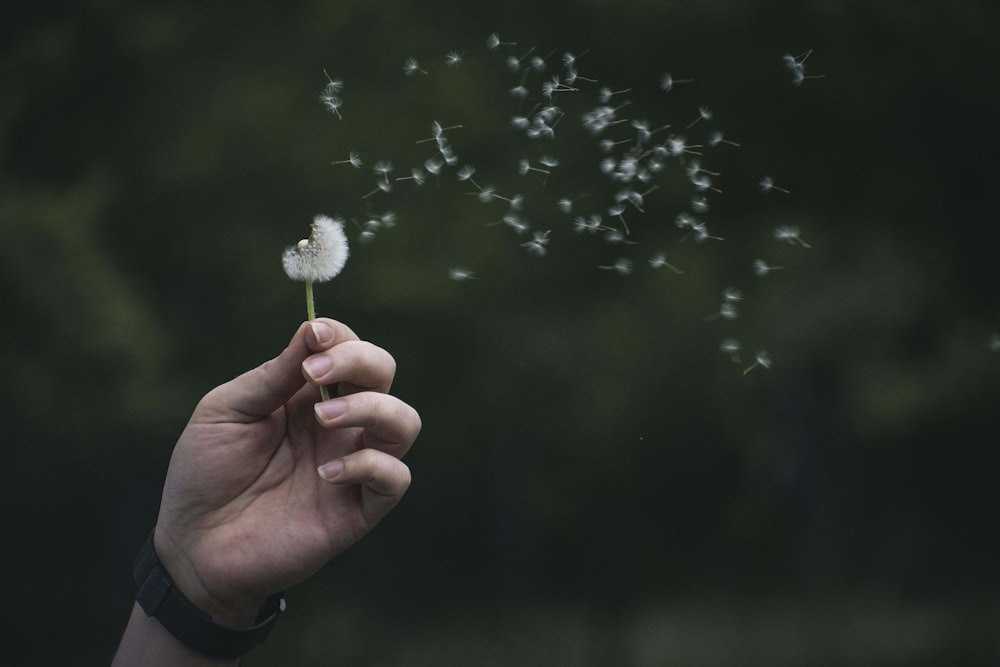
0,0,1000,666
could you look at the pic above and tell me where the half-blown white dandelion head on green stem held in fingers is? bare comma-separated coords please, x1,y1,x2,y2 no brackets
281,215,349,400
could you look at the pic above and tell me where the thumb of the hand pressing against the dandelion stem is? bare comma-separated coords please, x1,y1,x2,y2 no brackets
199,318,357,421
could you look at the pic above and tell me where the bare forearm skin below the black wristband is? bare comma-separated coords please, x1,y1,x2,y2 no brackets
111,604,240,667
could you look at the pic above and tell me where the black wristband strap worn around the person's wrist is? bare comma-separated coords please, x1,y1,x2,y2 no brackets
132,533,285,658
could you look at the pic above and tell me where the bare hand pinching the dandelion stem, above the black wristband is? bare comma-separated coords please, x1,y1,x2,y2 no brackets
154,318,420,627
